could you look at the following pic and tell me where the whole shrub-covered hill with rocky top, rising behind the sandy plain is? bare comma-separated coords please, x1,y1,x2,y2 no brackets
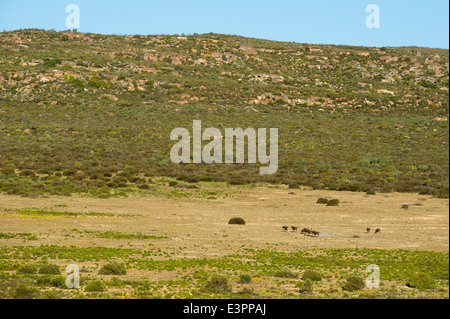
0,29,449,197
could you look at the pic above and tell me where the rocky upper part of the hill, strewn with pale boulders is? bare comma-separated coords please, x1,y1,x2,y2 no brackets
0,29,449,116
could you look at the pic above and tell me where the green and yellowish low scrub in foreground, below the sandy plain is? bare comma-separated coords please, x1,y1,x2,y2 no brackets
0,245,449,299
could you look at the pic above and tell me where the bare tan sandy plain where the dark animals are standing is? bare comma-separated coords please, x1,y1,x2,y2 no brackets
0,187,449,297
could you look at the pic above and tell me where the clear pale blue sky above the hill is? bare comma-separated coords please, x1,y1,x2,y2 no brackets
0,0,449,49
